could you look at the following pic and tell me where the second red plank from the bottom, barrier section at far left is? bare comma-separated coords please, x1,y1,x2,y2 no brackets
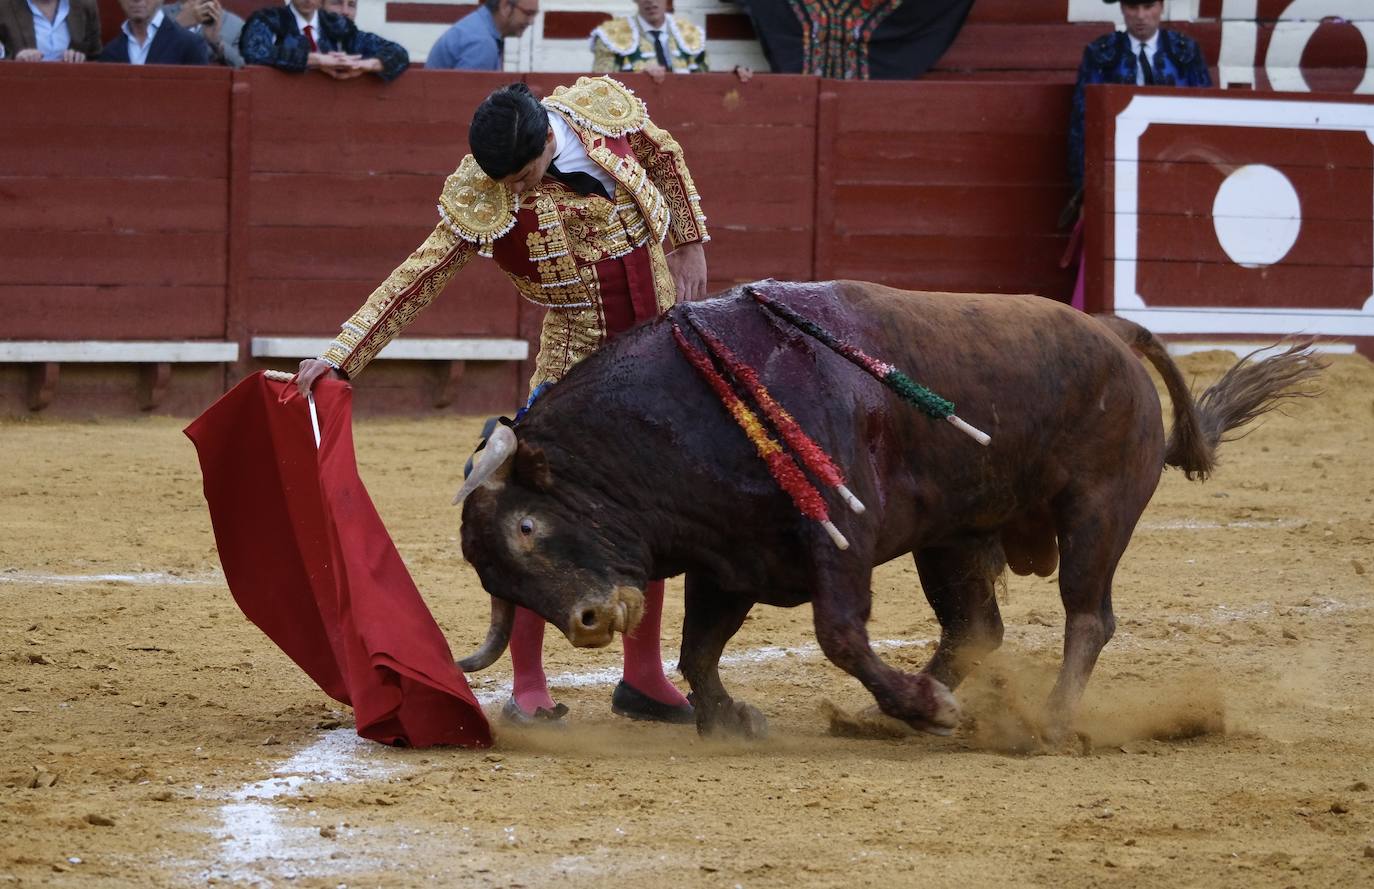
0,229,224,287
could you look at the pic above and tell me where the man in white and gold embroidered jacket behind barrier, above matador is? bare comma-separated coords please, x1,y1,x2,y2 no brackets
592,0,710,82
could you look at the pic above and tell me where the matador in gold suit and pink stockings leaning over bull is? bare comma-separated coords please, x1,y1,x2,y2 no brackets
297,77,708,723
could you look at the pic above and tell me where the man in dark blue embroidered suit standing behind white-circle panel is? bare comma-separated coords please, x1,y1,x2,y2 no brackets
1069,0,1212,190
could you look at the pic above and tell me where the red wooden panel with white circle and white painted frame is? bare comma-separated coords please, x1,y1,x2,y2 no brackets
1085,87,1374,349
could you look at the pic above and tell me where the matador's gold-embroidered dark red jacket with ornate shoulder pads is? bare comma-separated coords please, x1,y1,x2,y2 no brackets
322,77,709,389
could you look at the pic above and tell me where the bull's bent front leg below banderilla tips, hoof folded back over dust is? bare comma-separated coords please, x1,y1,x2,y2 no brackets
812,566,959,735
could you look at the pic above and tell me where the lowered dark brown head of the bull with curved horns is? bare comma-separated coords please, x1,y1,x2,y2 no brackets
453,426,647,672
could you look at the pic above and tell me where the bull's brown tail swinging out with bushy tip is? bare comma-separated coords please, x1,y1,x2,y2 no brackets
1098,316,1326,478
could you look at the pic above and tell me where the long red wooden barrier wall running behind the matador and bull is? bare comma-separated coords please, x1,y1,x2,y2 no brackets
0,65,1088,412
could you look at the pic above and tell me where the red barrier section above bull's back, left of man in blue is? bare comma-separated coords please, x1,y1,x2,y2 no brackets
816,81,1073,298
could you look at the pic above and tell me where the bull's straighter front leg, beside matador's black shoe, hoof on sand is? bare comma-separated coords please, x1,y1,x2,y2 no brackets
677,572,768,738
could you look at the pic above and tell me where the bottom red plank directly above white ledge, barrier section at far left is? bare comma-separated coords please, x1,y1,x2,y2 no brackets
0,283,224,339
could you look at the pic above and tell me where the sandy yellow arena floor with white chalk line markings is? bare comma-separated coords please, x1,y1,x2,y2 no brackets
0,353,1374,889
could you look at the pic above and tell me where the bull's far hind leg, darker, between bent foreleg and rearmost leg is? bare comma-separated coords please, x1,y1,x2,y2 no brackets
915,537,1006,688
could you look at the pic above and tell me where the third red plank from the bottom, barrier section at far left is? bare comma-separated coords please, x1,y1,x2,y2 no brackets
0,176,228,230
